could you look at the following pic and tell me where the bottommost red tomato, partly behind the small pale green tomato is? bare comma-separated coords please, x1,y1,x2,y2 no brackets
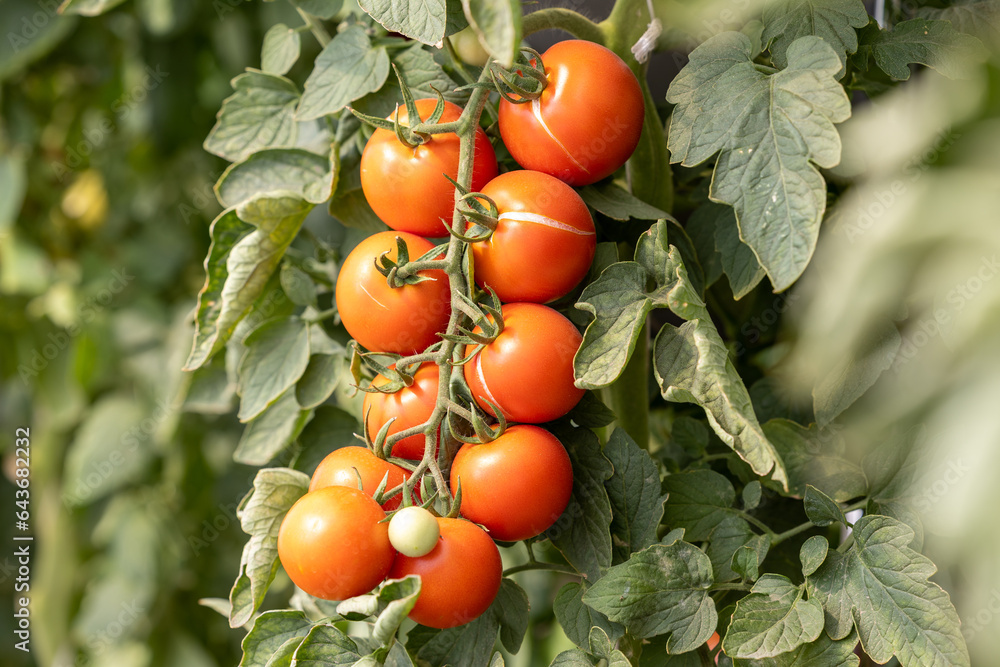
389,518,503,629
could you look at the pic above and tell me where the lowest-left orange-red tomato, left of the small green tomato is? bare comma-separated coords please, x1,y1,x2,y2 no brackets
278,486,396,600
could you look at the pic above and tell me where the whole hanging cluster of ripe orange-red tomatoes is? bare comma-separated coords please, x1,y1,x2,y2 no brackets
278,41,644,628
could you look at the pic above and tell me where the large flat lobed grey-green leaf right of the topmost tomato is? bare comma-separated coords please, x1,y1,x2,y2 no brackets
667,32,851,291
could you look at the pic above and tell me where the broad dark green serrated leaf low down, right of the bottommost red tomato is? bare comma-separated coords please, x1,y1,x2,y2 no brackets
583,542,718,653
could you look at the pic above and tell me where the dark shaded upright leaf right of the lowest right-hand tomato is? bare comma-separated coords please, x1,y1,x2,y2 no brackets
604,428,666,564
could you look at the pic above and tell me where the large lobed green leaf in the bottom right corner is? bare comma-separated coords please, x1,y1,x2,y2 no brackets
806,515,970,666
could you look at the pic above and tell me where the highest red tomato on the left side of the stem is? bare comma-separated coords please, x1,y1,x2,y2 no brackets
361,99,497,236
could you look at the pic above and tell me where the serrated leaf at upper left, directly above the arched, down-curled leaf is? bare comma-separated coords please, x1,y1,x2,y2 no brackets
205,70,299,162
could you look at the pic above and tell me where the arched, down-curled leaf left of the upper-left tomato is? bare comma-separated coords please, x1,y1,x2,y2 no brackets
215,148,337,208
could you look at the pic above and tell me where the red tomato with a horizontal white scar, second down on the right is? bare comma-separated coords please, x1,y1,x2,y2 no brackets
472,171,597,303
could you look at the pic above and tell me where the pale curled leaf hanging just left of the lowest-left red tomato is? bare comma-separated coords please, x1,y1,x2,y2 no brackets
229,468,309,628
